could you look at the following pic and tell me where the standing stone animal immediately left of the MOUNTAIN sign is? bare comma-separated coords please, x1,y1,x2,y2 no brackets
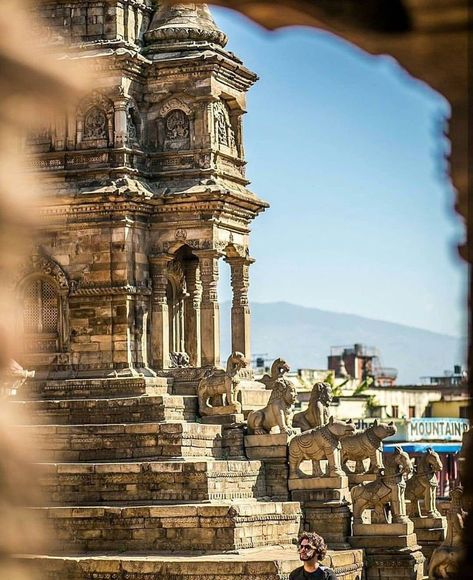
342,420,396,473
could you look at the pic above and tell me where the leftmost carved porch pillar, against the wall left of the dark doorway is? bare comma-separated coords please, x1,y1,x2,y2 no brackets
150,256,171,369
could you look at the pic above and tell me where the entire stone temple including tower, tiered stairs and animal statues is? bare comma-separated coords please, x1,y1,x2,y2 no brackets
11,0,458,580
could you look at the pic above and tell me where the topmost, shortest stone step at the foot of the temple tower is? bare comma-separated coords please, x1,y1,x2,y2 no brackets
17,377,173,399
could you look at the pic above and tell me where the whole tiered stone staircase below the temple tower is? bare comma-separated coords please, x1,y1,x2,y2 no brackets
16,378,352,580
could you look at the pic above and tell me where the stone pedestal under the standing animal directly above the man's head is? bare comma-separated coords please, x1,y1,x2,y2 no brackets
289,475,351,550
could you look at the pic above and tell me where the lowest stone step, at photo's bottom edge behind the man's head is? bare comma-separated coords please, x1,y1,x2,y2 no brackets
24,546,363,580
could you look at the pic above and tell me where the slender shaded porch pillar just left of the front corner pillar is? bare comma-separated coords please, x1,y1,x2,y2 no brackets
185,260,202,367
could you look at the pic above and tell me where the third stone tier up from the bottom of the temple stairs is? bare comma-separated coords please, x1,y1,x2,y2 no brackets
40,460,265,505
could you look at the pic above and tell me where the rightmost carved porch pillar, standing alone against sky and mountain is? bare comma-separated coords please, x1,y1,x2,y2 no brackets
225,257,254,361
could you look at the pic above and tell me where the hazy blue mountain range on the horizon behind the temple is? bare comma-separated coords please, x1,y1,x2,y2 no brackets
221,302,466,384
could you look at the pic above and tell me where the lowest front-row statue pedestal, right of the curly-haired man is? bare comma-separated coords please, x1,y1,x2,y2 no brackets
349,521,425,580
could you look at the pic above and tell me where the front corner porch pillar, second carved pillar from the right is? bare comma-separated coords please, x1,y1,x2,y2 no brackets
195,250,220,366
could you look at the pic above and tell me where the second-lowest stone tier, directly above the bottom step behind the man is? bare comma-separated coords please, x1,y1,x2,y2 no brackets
36,500,301,553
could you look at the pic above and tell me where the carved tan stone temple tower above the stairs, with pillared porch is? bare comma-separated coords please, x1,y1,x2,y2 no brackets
23,0,267,377
